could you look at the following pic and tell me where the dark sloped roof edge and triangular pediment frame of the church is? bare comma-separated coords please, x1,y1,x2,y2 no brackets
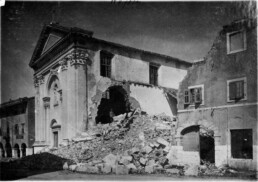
29,23,192,71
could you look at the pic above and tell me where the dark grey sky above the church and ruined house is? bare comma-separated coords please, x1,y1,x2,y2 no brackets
0,0,254,103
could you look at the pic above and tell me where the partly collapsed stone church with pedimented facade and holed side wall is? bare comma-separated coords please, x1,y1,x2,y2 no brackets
29,23,191,152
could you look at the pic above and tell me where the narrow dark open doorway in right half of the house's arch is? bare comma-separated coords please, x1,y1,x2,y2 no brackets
200,128,215,164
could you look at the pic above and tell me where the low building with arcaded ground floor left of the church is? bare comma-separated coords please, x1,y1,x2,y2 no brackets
0,97,35,158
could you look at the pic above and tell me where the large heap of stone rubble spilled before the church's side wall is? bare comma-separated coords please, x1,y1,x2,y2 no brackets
46,111,183,175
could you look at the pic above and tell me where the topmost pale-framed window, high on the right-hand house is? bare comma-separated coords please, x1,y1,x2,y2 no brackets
227,30,246,54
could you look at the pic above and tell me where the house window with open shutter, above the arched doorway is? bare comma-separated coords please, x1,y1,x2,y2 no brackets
184,85,204,104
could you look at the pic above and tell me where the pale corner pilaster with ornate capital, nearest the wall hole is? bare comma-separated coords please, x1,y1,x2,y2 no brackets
67,49,89,137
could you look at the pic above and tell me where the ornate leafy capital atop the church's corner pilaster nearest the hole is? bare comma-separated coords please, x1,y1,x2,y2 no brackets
66,50,89,66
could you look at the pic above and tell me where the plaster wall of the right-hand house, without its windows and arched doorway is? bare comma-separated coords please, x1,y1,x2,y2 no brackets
176,19,257,170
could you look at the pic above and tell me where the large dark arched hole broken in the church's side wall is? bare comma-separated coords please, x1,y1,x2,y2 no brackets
95,86,129,124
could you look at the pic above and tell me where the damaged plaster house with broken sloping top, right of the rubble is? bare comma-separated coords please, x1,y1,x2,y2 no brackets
171,19,258,170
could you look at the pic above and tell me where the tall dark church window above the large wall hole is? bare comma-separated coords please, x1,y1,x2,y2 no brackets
100,51,113,78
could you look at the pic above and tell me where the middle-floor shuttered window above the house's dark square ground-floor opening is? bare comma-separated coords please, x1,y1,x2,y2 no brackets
227,78,247,102
